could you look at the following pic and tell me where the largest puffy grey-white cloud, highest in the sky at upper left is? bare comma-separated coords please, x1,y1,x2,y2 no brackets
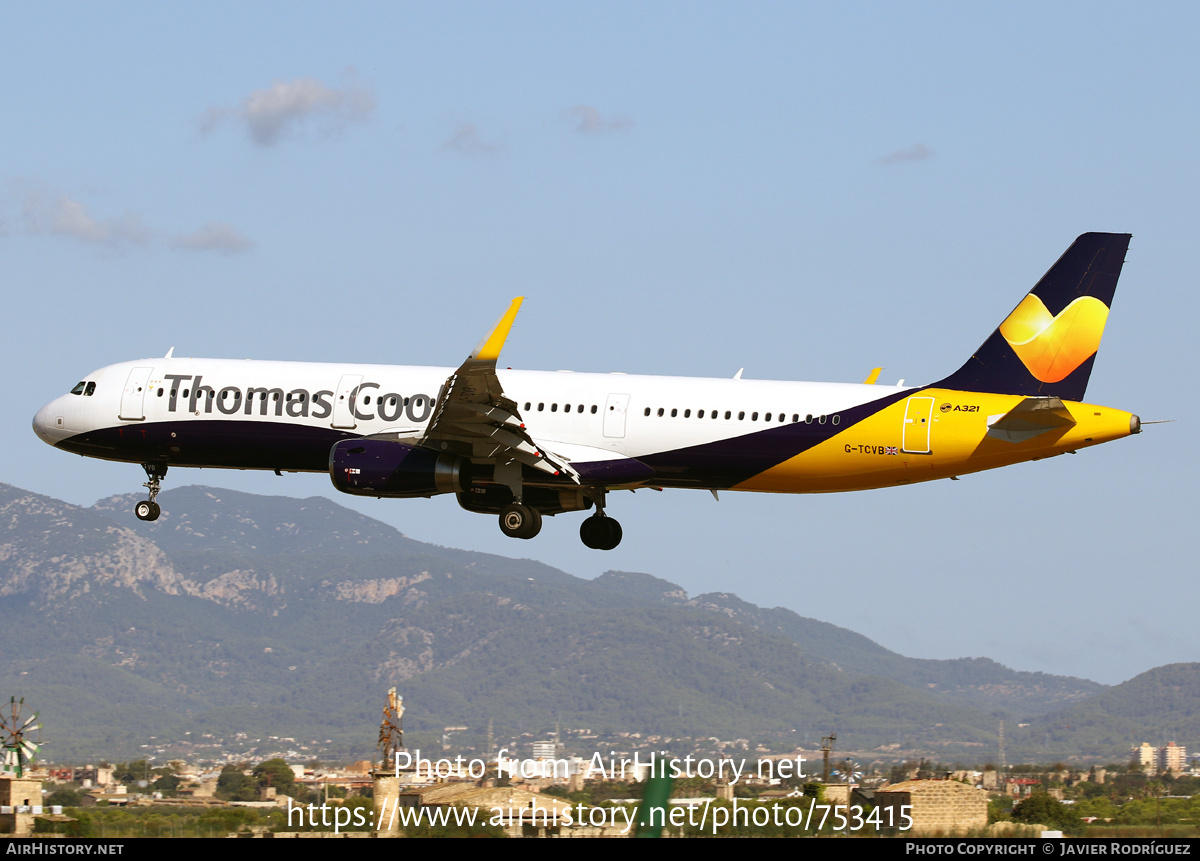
200,78,374,146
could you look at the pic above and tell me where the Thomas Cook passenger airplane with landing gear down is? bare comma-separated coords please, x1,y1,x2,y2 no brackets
34,233,1141,550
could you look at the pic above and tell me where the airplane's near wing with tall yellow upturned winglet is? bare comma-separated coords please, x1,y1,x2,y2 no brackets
420,296,580,483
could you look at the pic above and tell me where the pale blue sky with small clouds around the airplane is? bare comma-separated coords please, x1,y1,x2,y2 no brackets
0,2,1200,682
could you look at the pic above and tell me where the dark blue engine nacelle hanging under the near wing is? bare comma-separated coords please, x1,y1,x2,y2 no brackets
329,439,470,499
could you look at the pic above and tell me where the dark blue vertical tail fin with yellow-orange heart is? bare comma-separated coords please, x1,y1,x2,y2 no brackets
934,233,1130,401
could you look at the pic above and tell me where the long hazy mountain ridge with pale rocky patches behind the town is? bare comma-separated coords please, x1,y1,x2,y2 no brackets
0,486,1171,755
